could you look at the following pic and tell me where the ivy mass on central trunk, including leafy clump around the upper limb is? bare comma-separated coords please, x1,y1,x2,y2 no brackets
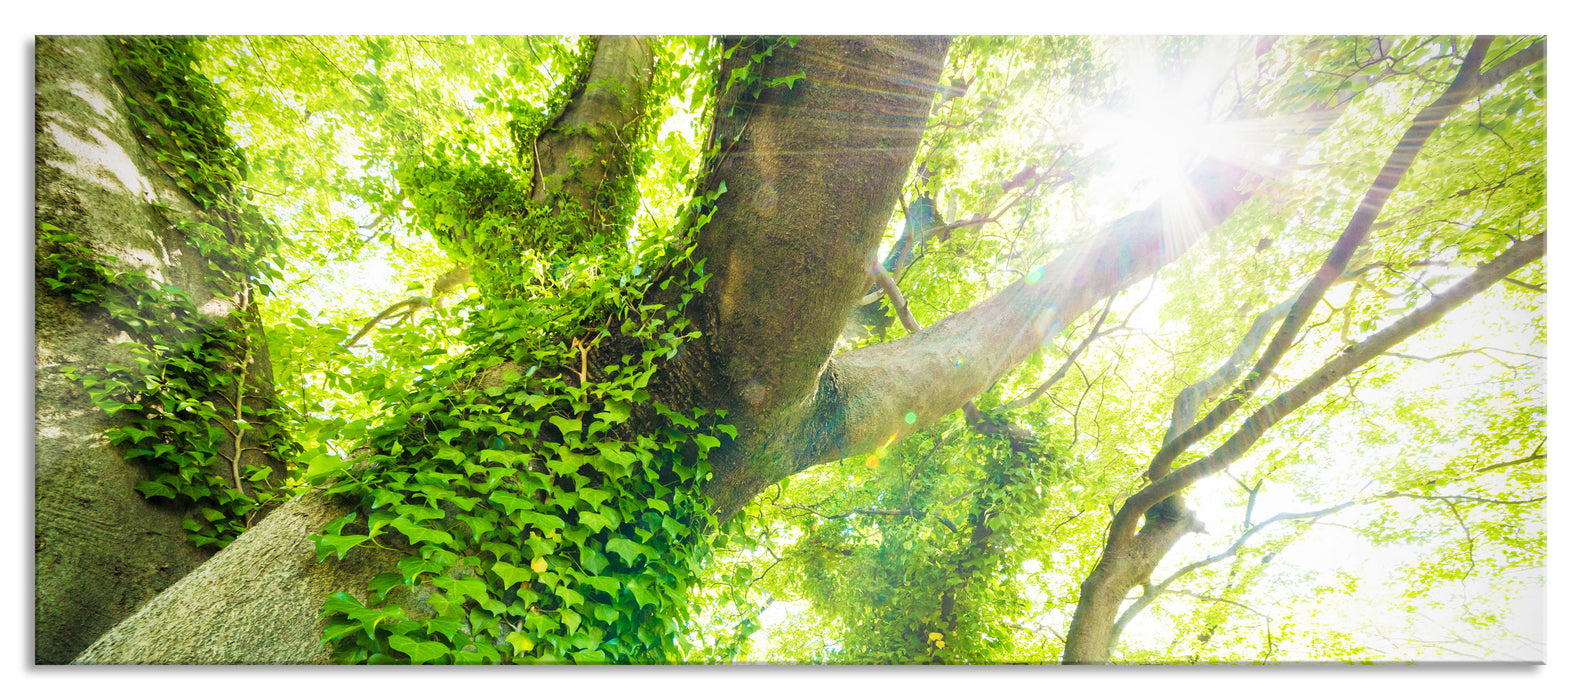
297,36,765,664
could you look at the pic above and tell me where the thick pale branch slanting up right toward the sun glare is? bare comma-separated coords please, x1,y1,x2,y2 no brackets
786,160,1258,474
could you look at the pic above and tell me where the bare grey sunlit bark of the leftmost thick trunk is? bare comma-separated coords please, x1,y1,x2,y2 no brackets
33,36,281,664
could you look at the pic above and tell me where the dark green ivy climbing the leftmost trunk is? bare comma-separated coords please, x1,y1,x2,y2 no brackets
38,38,294,548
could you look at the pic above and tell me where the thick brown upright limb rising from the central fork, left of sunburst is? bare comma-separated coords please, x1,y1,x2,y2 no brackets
658,36,949,515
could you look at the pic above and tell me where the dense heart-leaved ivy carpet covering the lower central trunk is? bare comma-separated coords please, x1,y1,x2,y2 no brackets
315,234,731,664
